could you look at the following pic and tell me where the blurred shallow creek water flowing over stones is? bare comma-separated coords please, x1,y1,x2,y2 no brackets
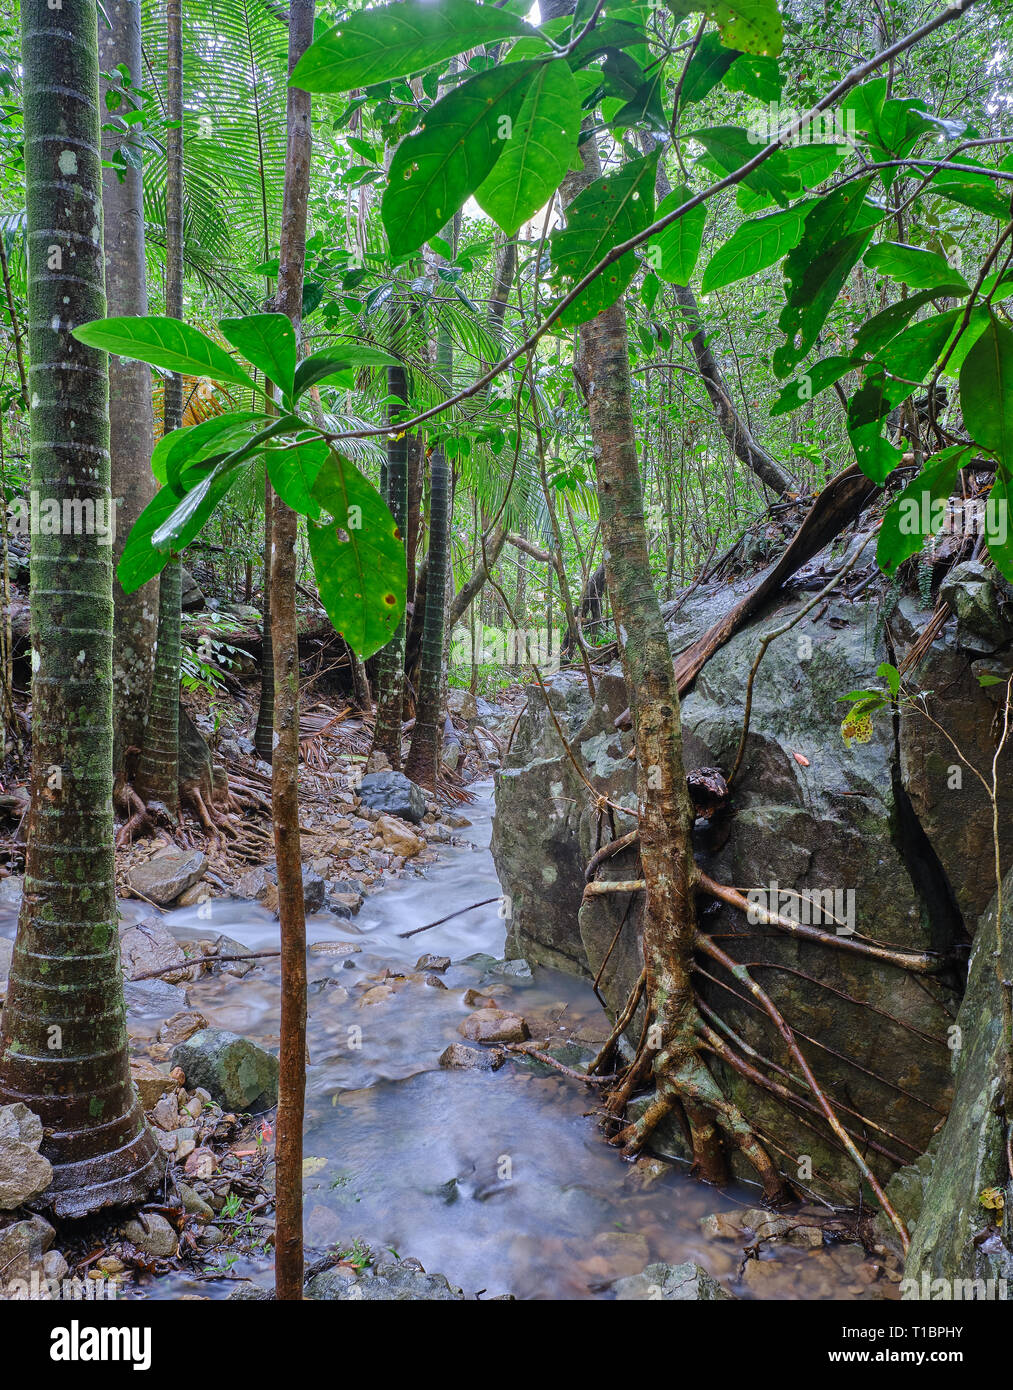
0,784,844,1300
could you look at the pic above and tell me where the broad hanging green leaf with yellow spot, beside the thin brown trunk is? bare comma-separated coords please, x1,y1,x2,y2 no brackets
308,453,407,660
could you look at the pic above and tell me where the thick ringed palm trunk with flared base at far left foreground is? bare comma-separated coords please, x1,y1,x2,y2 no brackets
0,0,164,1218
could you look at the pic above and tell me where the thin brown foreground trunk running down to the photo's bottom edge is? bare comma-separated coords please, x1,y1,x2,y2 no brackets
271,0,314,1301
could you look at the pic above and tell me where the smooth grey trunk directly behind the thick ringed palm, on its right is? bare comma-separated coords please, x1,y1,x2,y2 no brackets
99,0,158,776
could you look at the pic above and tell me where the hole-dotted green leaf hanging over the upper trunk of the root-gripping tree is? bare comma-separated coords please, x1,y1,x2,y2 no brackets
549,149,660,328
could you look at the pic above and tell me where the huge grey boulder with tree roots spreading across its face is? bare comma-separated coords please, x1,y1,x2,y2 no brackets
492,557,963,1195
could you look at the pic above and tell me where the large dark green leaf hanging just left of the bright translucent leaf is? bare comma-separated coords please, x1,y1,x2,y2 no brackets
381,61,543,260
